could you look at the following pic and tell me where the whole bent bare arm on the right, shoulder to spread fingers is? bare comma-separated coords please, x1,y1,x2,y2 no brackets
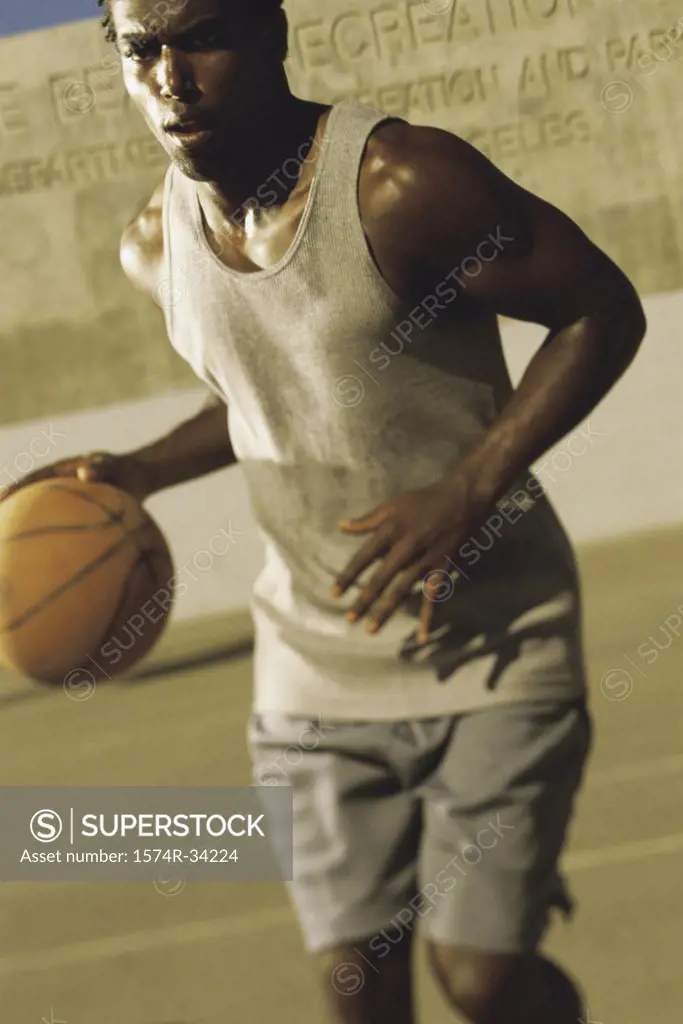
325,131,646,644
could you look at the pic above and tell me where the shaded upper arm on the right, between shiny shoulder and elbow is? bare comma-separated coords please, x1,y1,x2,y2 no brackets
413,140,640,329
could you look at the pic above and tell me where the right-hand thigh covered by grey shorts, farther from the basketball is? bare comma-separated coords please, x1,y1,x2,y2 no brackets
419,700,591,953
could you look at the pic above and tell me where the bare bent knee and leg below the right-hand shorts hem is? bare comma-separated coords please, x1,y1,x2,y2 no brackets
427,942,584,1024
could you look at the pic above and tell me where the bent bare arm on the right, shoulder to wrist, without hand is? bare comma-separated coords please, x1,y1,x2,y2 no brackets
367,126,646,507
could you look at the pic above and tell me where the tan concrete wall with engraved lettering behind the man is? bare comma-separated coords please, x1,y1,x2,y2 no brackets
0,0,683,424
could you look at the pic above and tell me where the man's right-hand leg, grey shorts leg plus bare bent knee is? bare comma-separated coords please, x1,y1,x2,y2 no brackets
420,701,591,1024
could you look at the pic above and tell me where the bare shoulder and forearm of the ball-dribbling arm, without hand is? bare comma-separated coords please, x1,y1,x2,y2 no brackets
121,180,238,492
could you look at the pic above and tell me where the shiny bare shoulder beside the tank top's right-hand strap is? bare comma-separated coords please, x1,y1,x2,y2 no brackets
359,122,524,258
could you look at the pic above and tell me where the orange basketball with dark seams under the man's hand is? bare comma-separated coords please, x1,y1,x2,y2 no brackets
0,478,173,685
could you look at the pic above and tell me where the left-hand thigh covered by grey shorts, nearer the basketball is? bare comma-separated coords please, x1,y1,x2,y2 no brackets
248,714,421,952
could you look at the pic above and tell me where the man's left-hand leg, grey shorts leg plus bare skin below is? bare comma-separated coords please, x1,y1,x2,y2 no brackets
249,715,421,1024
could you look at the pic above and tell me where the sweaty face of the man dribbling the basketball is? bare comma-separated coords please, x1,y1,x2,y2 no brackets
112,0,284,180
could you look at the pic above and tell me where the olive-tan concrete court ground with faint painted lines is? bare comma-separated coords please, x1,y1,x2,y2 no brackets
0,531,683,1024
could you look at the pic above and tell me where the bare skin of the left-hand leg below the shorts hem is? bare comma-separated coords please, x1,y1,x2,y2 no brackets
321,933,415,1024
